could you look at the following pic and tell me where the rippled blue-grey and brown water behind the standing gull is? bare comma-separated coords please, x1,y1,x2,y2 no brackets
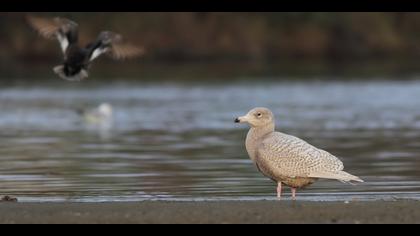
0,81,420,202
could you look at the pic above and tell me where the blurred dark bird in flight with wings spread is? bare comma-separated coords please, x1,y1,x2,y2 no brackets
27,16,144,81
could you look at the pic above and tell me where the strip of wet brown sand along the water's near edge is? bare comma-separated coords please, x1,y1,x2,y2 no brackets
0,201,420,224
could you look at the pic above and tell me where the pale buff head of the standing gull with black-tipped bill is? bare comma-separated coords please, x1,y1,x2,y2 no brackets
235,107,274,127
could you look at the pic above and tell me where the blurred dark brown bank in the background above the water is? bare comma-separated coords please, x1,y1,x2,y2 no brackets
0,12,420,79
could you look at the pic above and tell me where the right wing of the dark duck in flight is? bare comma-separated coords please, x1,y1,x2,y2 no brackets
87,31,144,61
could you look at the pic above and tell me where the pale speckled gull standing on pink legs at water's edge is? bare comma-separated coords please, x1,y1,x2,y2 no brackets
235,108,363,200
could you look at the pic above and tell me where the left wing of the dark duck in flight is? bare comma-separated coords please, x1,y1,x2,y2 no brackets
27,16,78,55
